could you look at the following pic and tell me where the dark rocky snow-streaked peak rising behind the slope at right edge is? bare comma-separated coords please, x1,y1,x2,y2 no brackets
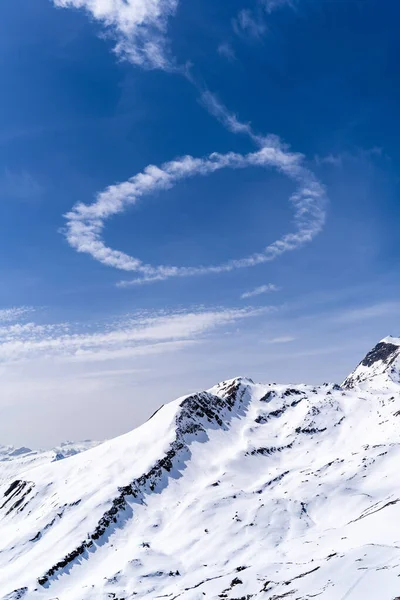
343,336,400,388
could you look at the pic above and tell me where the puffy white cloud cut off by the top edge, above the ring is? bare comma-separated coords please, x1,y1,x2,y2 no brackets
53,0,178,70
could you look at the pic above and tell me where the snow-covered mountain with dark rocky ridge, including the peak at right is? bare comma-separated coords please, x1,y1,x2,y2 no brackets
0,338,400,600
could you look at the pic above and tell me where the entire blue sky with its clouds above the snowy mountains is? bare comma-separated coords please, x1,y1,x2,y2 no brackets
0,0,400,445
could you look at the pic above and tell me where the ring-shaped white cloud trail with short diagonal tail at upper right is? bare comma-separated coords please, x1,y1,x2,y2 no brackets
66,92,326,286
